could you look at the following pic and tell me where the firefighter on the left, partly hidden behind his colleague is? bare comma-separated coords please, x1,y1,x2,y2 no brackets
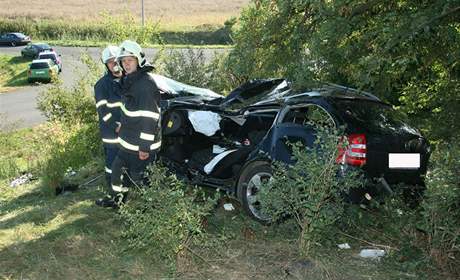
94,46,122,205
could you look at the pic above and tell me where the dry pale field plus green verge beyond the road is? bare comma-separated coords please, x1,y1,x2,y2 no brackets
0,0,249,46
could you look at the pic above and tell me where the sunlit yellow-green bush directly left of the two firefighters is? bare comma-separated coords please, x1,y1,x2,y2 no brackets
38,54,102,191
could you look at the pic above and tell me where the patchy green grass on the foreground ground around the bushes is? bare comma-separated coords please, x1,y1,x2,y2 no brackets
0,127,452,279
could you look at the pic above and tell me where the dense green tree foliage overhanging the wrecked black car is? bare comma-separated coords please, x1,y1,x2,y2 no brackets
228,0,460,139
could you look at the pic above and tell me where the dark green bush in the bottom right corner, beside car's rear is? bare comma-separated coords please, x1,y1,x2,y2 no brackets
341,143,460,279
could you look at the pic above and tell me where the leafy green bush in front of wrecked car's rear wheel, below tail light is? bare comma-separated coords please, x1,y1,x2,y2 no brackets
260,127,363,255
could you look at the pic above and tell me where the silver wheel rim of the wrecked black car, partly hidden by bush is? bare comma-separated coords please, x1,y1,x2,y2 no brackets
246,172,272,221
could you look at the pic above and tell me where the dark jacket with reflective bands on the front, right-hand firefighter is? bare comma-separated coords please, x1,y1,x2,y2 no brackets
118,65,161,153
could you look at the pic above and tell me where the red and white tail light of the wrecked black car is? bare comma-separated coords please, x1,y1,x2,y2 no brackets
336,134,367,166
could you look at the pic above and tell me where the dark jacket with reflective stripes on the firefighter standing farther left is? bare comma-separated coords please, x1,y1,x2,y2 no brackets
94,72,121,147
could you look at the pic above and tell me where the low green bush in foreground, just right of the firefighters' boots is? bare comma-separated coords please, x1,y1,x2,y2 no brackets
120,165,217,269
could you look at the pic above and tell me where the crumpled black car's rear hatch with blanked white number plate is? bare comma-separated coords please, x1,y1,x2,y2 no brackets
336,98,430,183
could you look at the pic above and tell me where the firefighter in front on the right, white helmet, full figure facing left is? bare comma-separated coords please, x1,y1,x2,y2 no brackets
96,40,161,208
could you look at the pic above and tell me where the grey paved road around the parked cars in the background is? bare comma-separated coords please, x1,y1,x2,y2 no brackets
0,46,220,129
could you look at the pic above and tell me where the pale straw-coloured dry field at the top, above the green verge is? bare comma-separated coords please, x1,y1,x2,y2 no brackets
0,0,250,27
